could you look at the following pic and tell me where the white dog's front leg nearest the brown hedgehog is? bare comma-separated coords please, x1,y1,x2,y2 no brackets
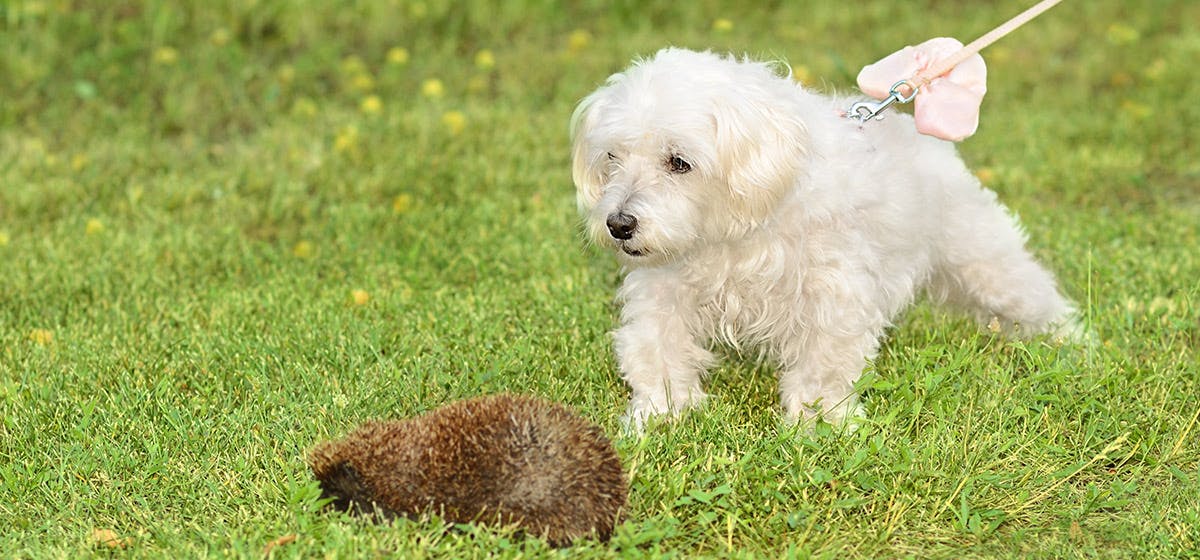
613,269,713,430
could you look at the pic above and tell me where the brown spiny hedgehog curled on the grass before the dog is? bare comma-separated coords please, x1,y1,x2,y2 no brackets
308,395,629,547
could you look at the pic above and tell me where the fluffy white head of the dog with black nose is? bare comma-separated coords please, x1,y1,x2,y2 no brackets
571,48,809,266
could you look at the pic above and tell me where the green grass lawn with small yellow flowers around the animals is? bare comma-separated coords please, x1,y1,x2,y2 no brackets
0,0,1200,559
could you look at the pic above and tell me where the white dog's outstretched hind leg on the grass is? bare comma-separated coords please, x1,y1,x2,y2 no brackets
929,188,1079,338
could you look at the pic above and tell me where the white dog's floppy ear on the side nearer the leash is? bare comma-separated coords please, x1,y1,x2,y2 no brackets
713,84,809,222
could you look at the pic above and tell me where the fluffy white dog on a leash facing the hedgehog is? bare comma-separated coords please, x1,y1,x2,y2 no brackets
571,48,1072,428
